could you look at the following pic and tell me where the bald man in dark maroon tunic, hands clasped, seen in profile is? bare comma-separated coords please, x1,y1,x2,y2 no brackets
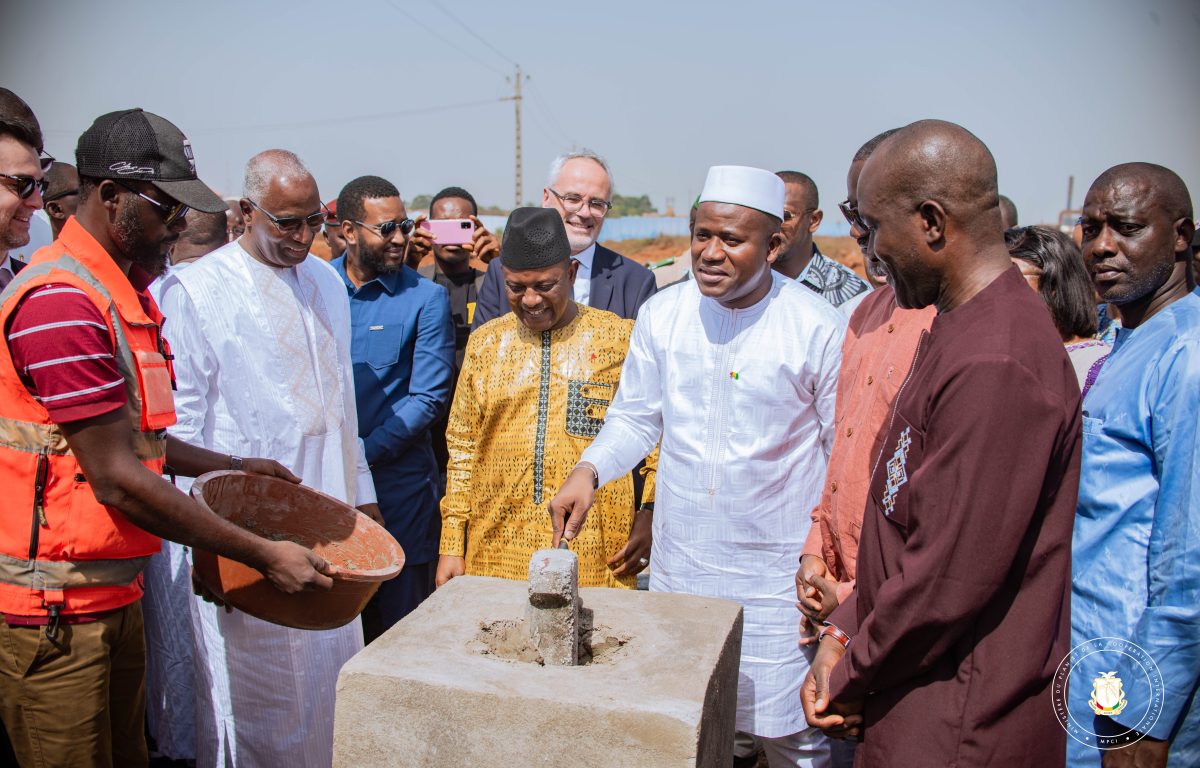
800,120,1080,766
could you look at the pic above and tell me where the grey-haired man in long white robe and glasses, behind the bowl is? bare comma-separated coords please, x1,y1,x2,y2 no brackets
162,150,379,768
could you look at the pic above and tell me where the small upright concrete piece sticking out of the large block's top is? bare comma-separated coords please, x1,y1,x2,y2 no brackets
526,550,580,666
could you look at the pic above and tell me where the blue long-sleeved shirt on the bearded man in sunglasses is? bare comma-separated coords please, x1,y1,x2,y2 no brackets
330,256,455,565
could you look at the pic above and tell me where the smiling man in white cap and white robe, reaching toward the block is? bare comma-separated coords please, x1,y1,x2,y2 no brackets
551,166,845,768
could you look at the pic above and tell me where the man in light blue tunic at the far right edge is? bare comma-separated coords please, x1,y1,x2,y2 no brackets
1069,163,1200,767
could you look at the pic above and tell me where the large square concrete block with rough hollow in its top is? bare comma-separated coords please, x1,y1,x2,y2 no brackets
334,576,742,768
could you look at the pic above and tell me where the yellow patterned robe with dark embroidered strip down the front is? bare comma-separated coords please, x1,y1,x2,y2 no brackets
440,305,656,588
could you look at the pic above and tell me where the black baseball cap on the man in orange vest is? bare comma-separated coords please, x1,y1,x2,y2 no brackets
76,109,228,214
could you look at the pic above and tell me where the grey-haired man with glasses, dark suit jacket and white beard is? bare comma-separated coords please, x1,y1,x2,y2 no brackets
472,150,656,329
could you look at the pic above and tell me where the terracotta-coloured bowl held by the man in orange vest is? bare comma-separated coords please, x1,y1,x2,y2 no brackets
192,470,404,629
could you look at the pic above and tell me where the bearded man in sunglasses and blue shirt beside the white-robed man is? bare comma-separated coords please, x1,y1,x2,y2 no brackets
331,176,455,642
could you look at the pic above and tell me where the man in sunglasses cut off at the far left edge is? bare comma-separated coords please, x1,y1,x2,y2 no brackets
0,88,43,290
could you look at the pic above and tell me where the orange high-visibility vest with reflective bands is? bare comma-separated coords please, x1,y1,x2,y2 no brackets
0,218,175,616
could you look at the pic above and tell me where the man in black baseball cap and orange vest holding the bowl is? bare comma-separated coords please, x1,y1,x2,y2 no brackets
0,109,332,766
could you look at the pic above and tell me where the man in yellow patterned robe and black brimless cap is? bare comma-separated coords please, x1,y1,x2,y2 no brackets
437,209,654,588
